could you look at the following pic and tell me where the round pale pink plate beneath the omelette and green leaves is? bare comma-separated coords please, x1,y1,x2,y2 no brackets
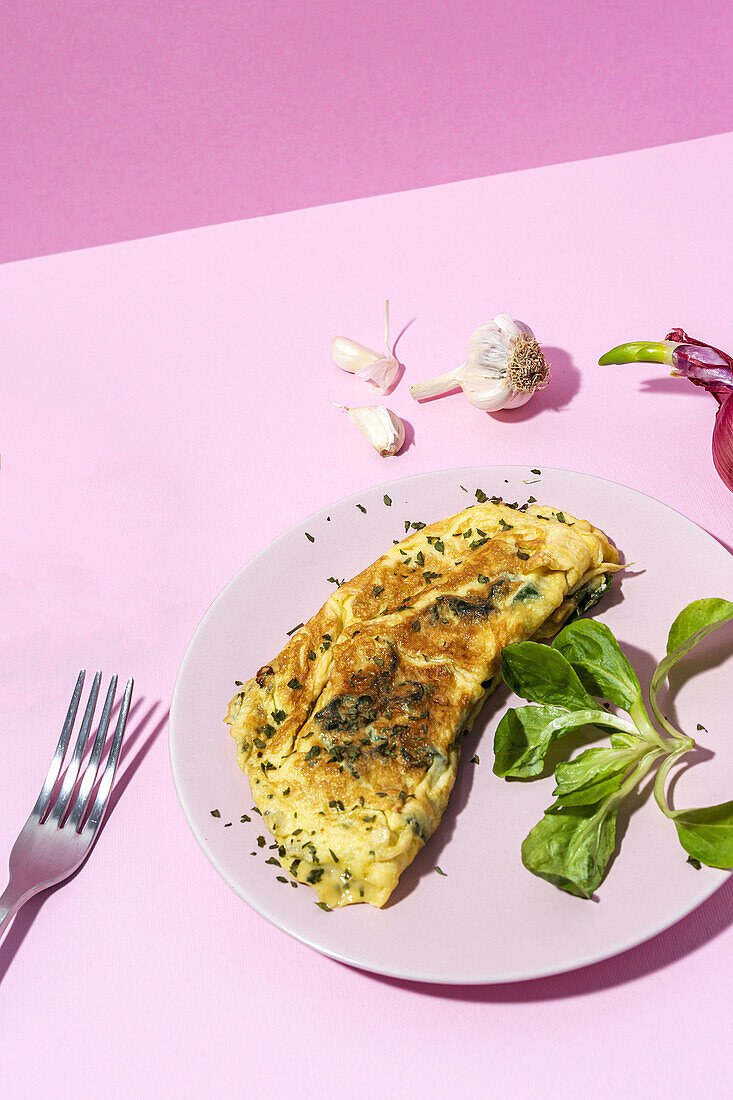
171,466,733,983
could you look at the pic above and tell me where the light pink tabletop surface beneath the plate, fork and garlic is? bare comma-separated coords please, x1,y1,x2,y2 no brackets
0,135,733,1097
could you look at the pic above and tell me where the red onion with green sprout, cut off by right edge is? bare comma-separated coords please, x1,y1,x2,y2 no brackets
599,329,733,493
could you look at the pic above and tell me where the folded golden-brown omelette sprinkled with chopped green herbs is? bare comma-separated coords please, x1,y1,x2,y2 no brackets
226,497,620,909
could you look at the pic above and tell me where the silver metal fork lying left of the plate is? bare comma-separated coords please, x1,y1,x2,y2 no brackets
0,669,133,939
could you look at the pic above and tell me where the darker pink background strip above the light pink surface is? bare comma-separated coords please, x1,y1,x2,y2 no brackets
0,0,733,261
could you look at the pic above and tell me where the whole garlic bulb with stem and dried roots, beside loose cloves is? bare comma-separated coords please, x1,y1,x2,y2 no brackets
409,314,549,413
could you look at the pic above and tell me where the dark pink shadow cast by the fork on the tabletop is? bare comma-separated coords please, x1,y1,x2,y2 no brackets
0,696,169,985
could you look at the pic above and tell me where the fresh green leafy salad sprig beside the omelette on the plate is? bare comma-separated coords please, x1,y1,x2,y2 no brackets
494,598,733,898
